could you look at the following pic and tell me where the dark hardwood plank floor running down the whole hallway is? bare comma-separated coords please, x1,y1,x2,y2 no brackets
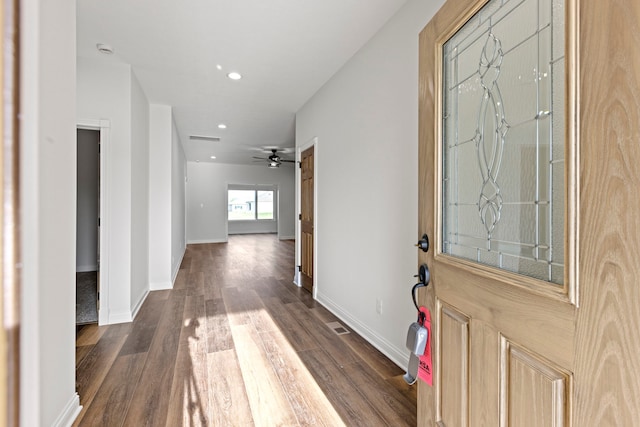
74,235,416,427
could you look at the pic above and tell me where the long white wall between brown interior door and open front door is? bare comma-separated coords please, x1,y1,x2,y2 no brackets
296,0,442,366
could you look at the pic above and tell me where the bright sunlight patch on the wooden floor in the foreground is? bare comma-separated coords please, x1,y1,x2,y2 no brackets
180,309,345,427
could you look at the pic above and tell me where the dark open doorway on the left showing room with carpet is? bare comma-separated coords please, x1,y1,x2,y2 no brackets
76,129,100,326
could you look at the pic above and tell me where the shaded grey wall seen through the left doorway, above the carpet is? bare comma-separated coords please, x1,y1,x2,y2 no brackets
76,129,100,271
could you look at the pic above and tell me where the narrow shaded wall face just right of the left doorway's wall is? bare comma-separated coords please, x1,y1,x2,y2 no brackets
130,71,151,310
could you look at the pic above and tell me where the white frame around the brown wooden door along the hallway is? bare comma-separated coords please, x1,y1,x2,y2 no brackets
293,136,318,299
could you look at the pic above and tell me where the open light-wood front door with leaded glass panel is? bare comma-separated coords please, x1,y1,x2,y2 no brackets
418,0,640,426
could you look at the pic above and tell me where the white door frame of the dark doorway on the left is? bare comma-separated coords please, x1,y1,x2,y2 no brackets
76,119,111,325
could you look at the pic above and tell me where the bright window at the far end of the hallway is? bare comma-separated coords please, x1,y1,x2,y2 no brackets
227,188,275,221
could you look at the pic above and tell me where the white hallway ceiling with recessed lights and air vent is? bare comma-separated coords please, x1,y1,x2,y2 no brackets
77,0,406,164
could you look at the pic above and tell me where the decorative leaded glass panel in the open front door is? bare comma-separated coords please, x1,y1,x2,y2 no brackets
442,0,565,284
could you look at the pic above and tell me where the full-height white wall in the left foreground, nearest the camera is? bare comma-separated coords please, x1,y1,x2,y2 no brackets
20,0,80,426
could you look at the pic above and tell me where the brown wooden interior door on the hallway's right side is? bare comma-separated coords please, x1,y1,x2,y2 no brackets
300,146,314,293
